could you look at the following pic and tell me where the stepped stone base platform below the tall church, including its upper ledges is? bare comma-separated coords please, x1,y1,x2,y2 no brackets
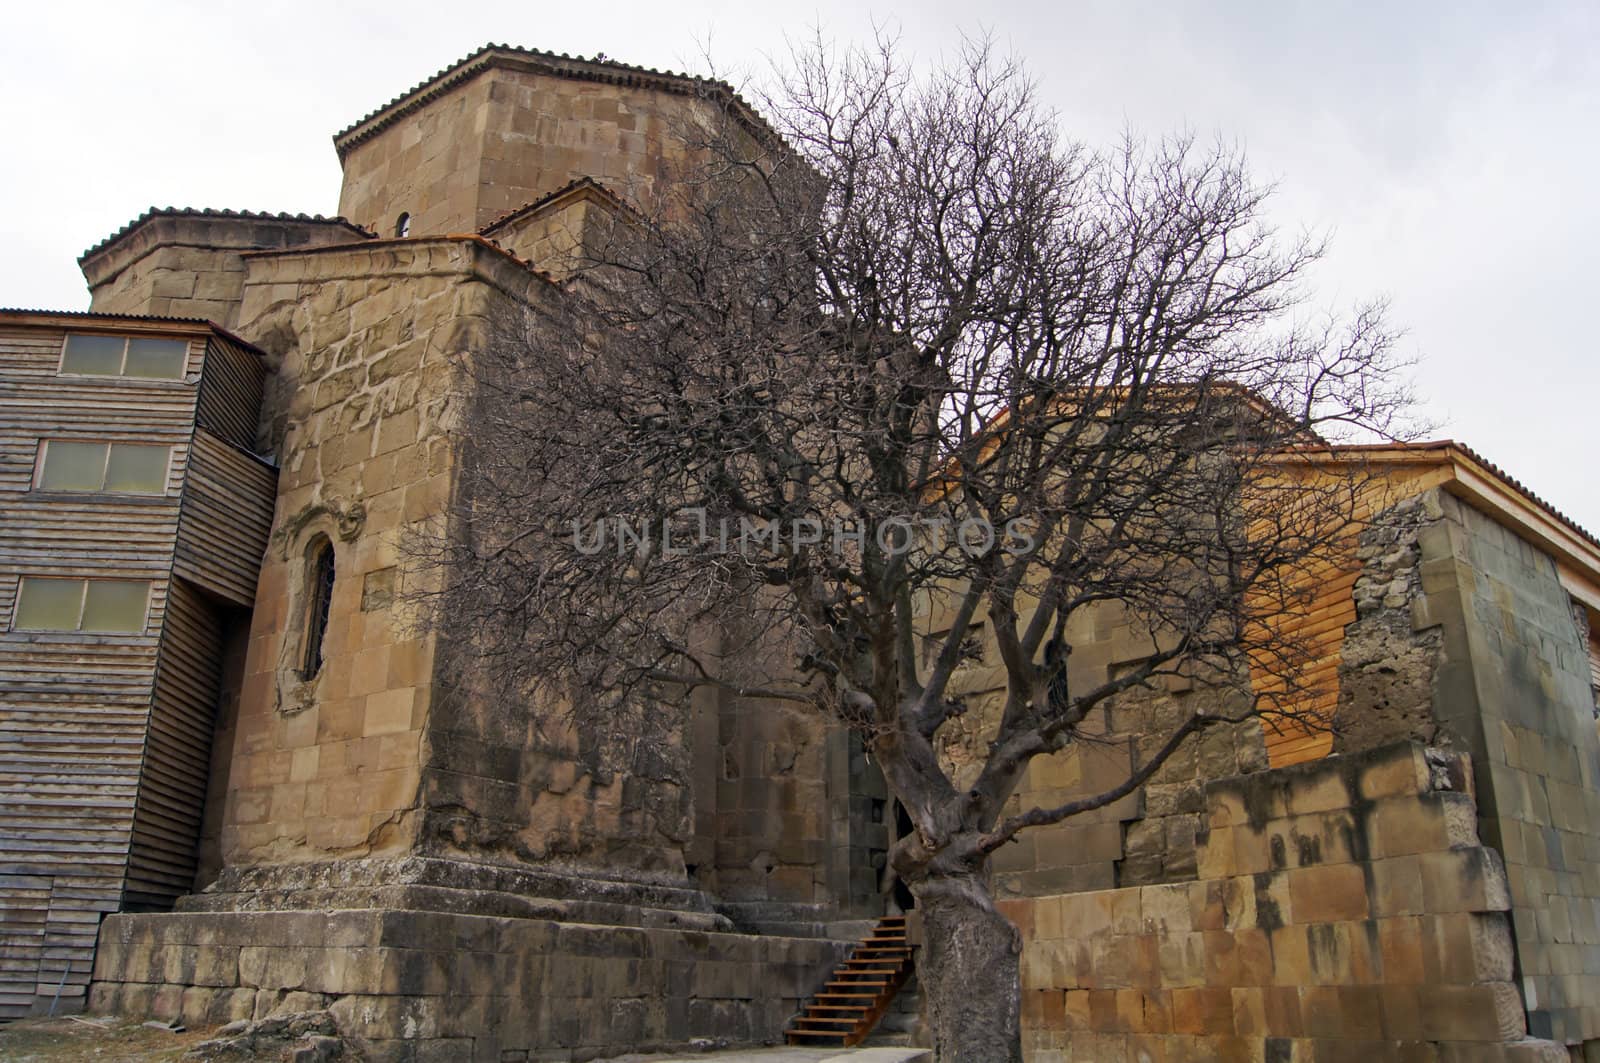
90,855,851,1063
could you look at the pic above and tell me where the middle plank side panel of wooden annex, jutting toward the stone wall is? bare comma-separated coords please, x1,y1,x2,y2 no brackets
173,429,278,605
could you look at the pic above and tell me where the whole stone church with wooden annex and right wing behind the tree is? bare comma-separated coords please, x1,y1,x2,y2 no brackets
9,45,1600,1063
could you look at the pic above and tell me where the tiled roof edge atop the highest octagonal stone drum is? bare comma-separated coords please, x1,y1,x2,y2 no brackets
333,43,770,158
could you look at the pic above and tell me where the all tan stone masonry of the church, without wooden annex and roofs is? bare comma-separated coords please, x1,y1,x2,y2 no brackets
21,37,1600,1063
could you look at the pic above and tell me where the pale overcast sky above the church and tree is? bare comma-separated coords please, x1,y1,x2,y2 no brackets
0,0,1600,532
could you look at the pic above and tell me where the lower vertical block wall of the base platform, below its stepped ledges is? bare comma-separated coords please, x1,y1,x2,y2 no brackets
90,909,848,1063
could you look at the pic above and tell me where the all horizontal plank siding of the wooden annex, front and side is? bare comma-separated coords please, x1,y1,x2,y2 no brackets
0,312,270,1020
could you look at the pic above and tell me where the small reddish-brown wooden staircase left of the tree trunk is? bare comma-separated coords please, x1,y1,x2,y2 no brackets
784,916,912,1049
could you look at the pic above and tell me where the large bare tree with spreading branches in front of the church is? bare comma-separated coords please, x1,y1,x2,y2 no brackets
422,42,1405,1060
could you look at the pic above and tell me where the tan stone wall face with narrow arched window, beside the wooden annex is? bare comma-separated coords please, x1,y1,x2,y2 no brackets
222,242,502,864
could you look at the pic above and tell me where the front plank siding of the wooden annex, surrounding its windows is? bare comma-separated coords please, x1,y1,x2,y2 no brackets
0,322,253,1018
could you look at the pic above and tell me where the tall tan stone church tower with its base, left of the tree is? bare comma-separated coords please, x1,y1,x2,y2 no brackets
83,46,888,1060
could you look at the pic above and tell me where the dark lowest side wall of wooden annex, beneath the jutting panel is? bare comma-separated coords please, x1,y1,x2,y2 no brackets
123,580,222,911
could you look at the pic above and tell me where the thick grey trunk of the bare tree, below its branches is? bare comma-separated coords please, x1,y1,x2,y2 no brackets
910,874,1022,1063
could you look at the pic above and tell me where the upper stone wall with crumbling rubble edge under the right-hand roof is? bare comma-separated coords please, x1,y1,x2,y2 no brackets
1336,490,1600,1044
